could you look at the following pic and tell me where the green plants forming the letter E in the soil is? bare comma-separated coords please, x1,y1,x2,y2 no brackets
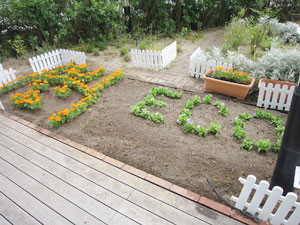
130,86,182,123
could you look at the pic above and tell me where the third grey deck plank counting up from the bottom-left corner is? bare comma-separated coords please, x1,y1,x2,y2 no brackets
0,171,71,224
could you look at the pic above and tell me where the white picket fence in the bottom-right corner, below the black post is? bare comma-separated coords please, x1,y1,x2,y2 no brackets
231,175,300,225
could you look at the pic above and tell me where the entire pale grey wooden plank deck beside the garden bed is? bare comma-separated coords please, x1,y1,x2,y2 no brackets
0,114,240,225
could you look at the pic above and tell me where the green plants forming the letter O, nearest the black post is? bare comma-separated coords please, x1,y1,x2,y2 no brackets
233,109,285,152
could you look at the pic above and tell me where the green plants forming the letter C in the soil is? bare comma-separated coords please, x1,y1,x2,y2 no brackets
177,94,229,137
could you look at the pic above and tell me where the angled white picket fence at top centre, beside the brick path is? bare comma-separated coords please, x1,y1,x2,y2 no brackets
130,41,177,70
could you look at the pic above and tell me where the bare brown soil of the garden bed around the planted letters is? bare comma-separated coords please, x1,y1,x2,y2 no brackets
0,78,287,201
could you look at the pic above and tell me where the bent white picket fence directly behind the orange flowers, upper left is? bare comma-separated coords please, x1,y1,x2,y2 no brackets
29,49,85,72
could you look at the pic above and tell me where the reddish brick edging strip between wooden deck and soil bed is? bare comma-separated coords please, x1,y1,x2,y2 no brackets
1,111,267,225
